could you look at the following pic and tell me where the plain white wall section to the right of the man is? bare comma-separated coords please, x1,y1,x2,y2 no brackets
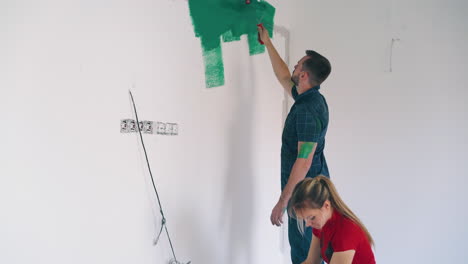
291,0,468,263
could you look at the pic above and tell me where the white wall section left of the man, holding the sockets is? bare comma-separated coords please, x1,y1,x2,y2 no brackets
0,0,296,264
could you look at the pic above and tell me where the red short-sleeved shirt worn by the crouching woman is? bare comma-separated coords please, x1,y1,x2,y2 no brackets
312,210,375,264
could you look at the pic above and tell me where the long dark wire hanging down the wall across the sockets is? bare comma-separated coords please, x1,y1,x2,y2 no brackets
128,91,191,264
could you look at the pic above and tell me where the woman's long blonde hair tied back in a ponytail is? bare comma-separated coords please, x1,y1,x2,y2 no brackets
288,175,374,245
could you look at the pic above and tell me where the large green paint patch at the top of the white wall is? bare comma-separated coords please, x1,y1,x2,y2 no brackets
189,0,275,88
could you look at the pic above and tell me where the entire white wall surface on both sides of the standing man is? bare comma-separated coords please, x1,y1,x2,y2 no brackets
4,0,468,264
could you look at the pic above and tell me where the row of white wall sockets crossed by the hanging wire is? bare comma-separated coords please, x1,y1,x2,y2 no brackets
120,119,179,136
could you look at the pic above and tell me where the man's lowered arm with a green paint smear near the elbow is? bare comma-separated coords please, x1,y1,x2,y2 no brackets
270,141,317,226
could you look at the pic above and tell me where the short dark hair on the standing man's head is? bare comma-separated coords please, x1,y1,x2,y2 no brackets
302,50,331,85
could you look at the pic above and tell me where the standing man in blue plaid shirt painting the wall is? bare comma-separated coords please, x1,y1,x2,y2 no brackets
258,26,331,264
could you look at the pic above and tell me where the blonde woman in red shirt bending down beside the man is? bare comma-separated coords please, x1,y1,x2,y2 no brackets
288,175,375,264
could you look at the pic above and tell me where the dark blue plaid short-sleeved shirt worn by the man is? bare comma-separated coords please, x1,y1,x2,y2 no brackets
281,86,330,190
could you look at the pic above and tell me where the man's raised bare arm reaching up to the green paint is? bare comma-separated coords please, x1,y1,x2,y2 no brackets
258,26,294,96
